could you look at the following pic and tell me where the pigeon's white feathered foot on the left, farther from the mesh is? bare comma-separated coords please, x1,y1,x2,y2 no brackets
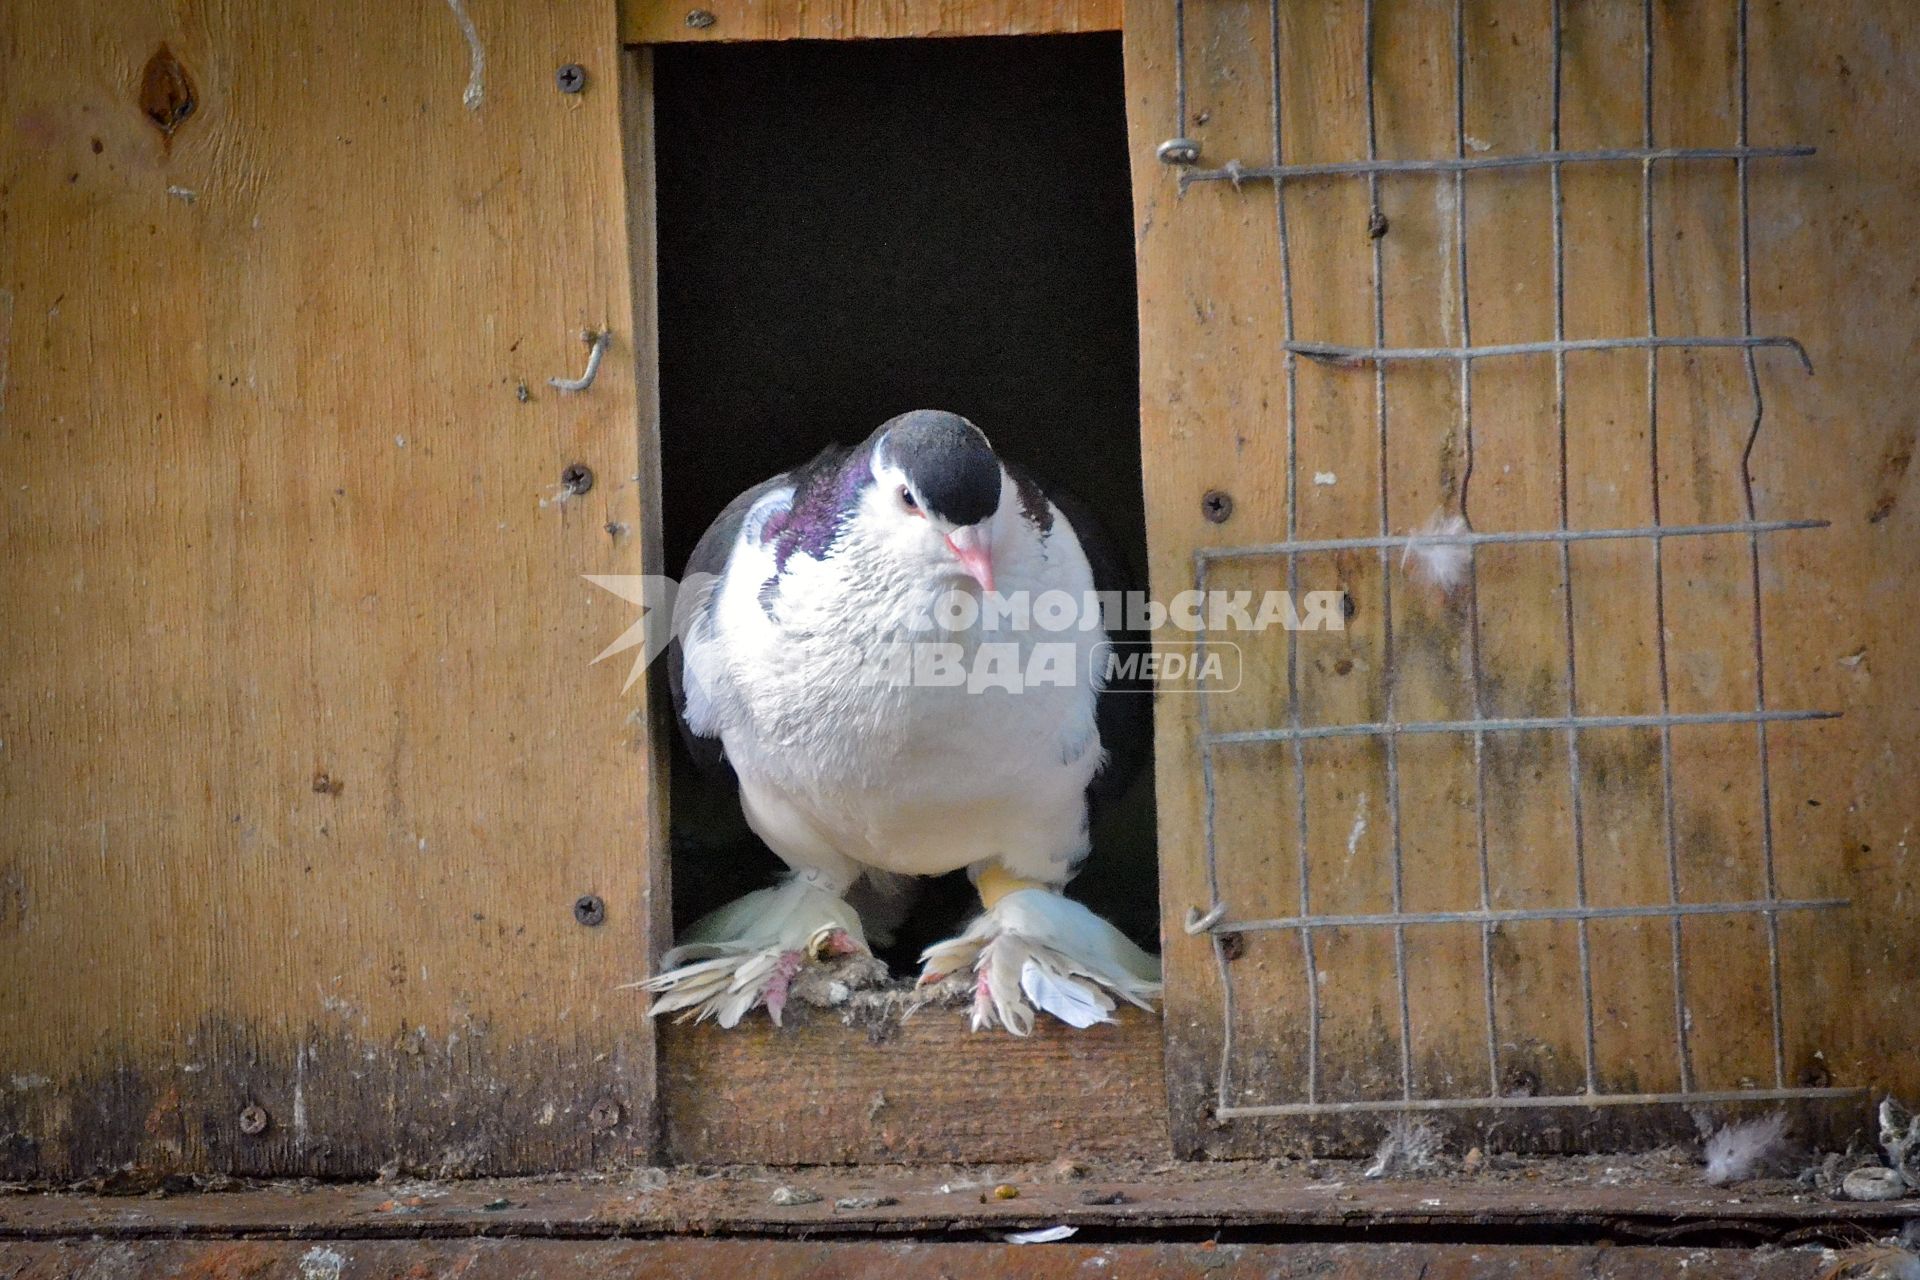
628,879,868,1027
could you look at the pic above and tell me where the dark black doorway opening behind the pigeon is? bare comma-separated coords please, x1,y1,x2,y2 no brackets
655,35,1158,973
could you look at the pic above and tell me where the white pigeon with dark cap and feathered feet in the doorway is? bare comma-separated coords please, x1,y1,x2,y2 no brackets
637,409,1160,1036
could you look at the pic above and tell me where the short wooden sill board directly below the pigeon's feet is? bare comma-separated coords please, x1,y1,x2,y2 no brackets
660,1009,1167,1165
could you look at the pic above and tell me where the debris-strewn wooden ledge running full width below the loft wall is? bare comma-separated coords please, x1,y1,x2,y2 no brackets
0,1159,1920,1243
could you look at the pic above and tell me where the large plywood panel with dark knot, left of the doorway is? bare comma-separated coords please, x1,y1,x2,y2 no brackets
0,0,655,1178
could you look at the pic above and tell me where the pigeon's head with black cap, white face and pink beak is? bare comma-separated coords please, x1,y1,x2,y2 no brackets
866,409,1006,591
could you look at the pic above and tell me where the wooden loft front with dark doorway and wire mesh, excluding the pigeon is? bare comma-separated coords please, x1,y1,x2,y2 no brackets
0,0,1920,1205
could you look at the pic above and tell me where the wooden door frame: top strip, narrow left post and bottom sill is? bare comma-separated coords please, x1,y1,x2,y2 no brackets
620,0,1169,1165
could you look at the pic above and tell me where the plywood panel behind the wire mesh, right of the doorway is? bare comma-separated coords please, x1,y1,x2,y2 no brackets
1125,0,1920,1155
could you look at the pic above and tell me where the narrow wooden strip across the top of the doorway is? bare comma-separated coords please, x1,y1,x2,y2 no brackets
620,0,1121,44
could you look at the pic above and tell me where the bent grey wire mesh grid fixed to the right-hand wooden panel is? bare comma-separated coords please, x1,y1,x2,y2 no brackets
1162,0,1859,1121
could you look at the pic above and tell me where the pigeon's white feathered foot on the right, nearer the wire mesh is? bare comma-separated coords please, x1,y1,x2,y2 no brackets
920,875,1160,1036
